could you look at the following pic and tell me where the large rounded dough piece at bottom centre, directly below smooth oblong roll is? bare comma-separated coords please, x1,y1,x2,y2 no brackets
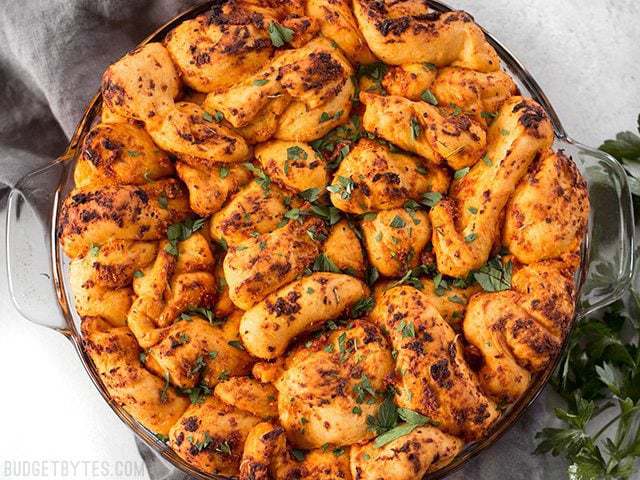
276,322,394,448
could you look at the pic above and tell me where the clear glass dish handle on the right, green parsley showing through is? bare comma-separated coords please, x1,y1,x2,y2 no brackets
555,138,634,318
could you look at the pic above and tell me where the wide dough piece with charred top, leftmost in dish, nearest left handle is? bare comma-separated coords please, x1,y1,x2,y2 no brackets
58,179,190,258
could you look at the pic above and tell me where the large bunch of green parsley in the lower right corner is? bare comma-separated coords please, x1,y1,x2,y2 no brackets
536,292,640,480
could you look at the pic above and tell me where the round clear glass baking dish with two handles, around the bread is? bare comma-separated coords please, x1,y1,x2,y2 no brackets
6,0,633,479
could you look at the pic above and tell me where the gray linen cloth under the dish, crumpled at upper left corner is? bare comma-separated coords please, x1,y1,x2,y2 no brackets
0,0,566,480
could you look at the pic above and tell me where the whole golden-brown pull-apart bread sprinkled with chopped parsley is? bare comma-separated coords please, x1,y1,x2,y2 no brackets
58,0,589,480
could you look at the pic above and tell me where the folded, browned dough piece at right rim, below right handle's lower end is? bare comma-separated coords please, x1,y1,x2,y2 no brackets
463,255,579,401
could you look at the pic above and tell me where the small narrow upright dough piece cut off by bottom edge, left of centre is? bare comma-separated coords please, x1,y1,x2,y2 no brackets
240,422,285,480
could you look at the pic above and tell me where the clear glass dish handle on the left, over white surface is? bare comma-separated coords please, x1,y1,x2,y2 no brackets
5,158,68,335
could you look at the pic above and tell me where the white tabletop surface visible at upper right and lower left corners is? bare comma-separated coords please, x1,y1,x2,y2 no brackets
0,0,640,479
